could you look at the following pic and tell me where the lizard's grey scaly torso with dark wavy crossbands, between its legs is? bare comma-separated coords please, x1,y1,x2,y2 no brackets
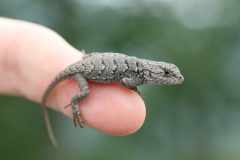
79,53,142,83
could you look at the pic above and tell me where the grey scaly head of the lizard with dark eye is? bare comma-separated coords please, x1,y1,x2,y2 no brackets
143,61,184,85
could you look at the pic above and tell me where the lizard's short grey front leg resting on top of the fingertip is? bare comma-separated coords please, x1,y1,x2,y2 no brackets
121,78,143,99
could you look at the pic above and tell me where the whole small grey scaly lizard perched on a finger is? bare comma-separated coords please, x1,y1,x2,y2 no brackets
41,52,184,146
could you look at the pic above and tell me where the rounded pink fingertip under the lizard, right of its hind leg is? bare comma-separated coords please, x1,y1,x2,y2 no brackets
80,83,146,136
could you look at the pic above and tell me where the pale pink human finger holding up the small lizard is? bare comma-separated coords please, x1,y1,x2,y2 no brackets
0,18,146,136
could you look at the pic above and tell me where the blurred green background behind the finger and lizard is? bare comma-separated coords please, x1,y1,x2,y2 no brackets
0,0,240,160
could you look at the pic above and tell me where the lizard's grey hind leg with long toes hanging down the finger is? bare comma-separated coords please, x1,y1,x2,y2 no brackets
64,73,89,128
